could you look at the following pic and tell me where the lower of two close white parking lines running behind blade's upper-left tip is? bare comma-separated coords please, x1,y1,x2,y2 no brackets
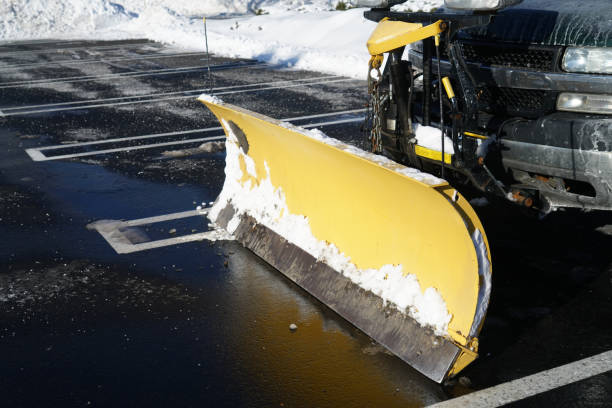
3,78,354,116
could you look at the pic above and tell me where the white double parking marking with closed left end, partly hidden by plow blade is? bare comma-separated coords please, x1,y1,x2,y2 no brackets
25,114,363,161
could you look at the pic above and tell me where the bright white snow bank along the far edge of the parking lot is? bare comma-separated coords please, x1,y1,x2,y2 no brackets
0,0,441,79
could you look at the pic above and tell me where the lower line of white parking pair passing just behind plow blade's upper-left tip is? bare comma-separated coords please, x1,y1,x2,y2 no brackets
2,77,355,116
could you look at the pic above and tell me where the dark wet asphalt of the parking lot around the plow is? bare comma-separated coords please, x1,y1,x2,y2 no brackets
0,40,612,407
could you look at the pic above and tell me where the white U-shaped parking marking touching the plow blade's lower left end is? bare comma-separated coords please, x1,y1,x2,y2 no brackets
87,208,232,254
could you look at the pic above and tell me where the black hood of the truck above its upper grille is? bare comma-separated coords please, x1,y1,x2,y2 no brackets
460,0,612,47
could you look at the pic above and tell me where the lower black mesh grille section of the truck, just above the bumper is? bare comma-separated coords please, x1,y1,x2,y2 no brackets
478,87,557,117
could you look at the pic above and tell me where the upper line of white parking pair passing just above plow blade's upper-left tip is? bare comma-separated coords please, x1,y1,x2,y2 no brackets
2,75,340,112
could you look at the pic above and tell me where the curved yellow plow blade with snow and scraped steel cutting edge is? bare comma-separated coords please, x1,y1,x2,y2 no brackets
200,95,491,382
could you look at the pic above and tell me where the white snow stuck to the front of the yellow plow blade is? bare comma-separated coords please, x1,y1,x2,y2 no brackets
208,106,452,335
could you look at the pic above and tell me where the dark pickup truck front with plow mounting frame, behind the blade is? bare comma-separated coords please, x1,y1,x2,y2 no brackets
360,0,612,213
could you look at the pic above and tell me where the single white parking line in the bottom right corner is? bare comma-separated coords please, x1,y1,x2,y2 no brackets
431,350,612,408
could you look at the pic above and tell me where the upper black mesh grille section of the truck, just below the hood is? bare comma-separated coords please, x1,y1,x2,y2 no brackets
461,42,557,71
